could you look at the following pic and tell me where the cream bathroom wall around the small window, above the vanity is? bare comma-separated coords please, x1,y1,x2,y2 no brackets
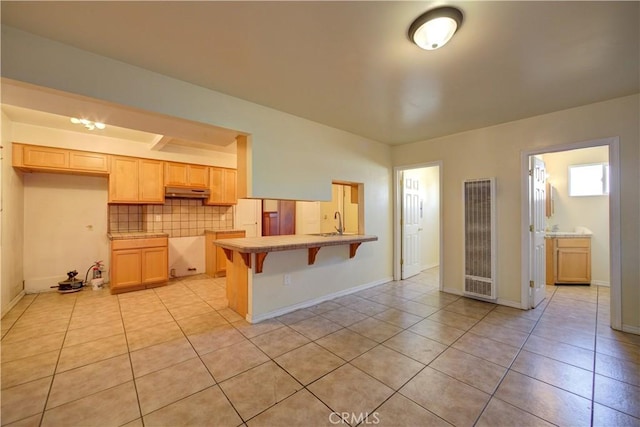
542,147,609,286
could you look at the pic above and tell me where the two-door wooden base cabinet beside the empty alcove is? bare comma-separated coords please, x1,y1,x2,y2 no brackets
110,237,169,293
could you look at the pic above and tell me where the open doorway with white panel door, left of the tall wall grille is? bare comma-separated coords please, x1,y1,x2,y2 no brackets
394,162,443,289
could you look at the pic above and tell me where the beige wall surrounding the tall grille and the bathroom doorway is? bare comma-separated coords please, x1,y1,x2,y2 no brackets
392,95,640,332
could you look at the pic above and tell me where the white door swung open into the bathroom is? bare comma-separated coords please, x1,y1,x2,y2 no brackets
529,156,546,308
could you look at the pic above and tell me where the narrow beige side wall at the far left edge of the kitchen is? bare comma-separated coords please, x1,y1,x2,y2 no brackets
0,113,24,315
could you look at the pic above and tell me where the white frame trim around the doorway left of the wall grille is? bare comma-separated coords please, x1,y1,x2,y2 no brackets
393,160,445,290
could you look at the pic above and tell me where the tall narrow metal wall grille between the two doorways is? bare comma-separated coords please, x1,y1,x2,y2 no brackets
463,178,497,300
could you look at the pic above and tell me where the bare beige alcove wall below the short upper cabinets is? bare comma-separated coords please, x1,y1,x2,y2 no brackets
24,173,109,292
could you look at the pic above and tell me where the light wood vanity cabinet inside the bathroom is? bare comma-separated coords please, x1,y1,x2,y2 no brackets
546,237,591,285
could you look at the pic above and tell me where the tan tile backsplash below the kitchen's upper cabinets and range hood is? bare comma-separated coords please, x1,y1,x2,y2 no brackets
109,199,233,237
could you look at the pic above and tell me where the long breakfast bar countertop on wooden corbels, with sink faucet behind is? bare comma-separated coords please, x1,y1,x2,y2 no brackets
214,234,378,253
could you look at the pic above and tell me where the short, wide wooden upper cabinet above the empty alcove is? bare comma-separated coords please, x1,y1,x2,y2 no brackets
13,143,109,176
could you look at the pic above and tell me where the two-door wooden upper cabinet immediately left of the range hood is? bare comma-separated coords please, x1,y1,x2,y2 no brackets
109,156,164,204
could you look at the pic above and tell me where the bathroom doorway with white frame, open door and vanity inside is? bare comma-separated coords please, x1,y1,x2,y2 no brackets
521,137,622,329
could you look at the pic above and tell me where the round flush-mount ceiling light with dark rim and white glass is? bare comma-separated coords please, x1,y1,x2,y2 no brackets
409,6,462,50
